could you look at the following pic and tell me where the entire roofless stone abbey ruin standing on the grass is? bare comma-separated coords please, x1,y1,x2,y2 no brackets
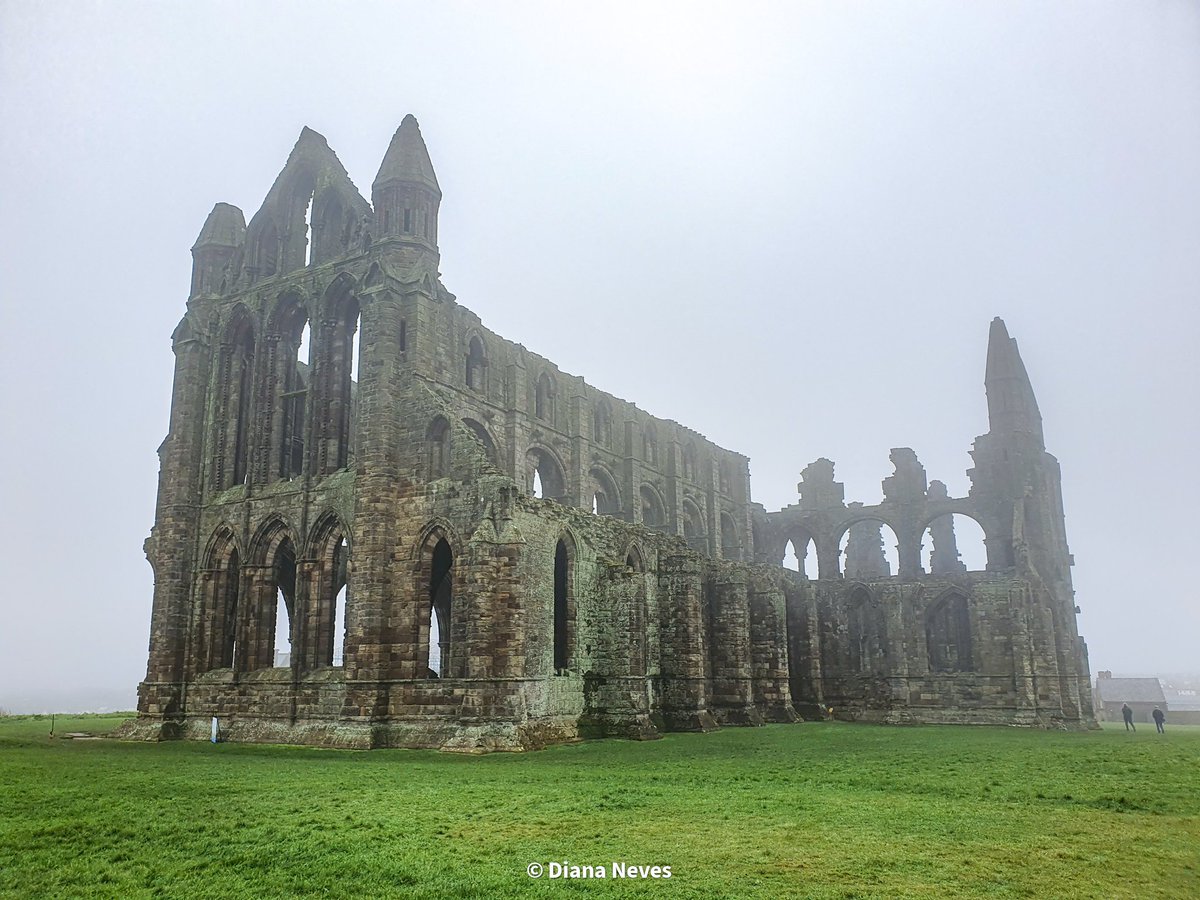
126,116,1094,751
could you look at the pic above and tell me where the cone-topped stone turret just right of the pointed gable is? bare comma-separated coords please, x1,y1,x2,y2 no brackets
371,115,442,251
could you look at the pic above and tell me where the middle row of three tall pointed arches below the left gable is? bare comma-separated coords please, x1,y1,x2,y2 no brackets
211,282,374,490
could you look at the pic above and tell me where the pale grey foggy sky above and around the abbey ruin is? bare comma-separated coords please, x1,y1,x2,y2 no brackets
0,0,1200,709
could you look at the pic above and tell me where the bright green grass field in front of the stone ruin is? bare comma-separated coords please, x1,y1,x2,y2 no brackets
0,716,1200,898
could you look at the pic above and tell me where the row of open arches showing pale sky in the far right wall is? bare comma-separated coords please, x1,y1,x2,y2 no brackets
781,512,988,580
